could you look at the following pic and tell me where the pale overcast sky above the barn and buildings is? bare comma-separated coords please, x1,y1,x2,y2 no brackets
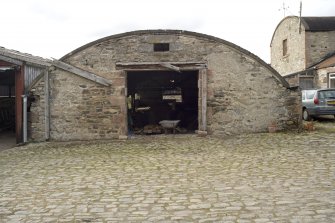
0,0,335,63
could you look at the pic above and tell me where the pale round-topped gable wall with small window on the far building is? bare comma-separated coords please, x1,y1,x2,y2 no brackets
271,17,306,76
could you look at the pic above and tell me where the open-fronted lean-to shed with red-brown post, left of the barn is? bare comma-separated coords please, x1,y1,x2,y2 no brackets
0,47,51,143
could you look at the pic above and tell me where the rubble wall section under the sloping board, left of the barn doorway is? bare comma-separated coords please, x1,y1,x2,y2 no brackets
46,69,126,141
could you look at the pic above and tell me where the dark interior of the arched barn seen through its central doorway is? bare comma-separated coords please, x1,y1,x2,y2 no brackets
127,71,198,134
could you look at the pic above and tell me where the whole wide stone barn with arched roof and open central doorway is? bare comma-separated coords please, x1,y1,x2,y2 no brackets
29,30,301,141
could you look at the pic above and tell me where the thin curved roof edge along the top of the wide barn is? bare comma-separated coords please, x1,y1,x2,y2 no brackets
60,30,289,88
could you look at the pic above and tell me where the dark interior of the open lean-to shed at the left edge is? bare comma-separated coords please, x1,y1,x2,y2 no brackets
0,64,15,139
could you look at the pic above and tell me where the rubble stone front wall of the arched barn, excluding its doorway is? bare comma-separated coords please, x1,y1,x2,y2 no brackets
31,31,301,141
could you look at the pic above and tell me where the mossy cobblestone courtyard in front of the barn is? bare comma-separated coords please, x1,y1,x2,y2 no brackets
0,122,335,222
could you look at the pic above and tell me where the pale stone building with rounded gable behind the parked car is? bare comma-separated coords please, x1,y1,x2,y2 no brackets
271,16,335,89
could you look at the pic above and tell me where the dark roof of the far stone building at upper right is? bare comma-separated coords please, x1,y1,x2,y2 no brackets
301,16,335,32
